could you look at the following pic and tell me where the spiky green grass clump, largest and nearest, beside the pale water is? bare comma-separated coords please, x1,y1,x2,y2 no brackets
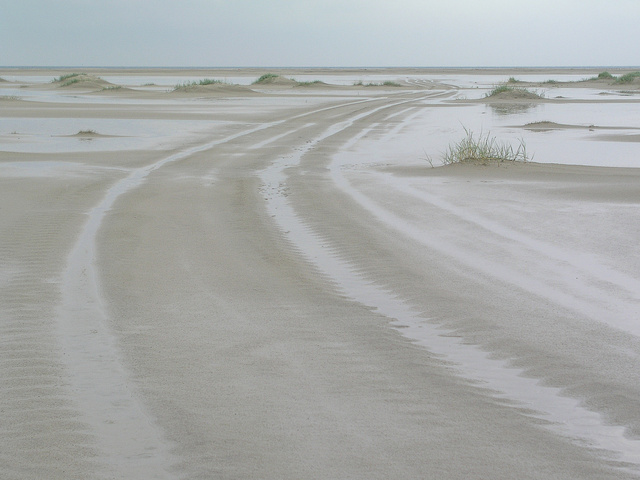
443,128,529,165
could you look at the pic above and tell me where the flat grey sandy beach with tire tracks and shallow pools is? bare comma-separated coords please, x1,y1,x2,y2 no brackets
0,68,640,480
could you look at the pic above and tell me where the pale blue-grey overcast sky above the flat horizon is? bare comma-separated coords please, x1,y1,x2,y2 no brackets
0,0,640,67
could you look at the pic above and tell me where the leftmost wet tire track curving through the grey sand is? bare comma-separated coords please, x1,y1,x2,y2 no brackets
57,92,424,479
